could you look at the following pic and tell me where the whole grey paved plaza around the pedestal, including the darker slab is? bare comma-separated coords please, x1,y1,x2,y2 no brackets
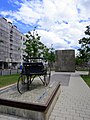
0,71,90,120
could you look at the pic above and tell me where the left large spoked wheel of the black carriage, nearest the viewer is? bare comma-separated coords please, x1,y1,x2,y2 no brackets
17,75,27,94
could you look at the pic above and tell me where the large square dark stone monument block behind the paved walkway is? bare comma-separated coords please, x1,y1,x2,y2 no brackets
55,50,75,72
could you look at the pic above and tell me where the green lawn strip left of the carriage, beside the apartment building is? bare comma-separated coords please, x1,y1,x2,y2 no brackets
0,74,19,88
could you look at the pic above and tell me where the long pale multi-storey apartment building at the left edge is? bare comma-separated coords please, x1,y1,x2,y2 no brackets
0,18,25,69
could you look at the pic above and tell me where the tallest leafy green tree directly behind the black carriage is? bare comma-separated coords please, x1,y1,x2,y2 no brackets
23,29,44,61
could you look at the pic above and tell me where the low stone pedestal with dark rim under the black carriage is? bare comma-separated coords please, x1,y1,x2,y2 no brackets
0,81,60,120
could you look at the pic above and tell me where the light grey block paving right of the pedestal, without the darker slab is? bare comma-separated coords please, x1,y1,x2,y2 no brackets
51,72,90,120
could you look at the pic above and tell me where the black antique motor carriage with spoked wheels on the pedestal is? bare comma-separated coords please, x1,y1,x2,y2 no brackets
17,57,51,94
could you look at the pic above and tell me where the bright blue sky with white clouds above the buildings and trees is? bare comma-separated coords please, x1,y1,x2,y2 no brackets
0,0,90,53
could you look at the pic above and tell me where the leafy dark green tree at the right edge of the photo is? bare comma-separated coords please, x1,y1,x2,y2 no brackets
78,25,90,72
